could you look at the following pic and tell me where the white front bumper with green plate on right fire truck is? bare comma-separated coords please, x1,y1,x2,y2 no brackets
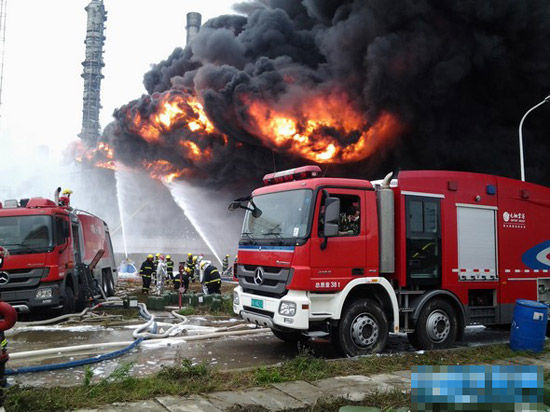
233,286,311,330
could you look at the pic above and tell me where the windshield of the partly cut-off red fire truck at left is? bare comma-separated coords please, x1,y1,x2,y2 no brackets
0,215,53,255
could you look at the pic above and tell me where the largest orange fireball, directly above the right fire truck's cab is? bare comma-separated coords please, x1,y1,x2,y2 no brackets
248,93,402,163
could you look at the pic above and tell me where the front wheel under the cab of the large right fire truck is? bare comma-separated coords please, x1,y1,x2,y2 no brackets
333,299,389,356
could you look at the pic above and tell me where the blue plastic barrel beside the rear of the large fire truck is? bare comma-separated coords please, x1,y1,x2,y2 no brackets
510,299,548,352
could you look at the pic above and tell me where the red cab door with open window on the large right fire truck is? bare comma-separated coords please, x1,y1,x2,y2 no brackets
310,189,367,289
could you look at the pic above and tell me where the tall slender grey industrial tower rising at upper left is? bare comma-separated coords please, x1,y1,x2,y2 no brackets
78,0,107,147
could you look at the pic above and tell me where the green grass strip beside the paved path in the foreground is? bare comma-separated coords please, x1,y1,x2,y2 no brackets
5,344,549,411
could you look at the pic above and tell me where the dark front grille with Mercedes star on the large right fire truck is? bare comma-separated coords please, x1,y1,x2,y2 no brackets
237,265,292,298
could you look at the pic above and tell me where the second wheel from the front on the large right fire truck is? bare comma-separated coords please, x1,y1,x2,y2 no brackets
409,299,458,350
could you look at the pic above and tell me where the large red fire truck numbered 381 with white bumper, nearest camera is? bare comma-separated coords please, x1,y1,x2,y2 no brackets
230,166,550,356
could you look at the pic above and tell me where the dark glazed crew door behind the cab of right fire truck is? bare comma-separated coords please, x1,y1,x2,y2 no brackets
405,196,441,286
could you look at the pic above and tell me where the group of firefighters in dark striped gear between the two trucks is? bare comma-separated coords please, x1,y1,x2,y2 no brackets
139,253,235,295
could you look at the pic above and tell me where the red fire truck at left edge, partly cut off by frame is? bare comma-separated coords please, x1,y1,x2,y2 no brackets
0,189,117,313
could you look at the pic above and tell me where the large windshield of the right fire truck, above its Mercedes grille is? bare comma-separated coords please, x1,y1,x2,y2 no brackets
242,189,313,241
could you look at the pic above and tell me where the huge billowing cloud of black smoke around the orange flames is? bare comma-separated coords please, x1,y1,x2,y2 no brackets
103,0,550,185
